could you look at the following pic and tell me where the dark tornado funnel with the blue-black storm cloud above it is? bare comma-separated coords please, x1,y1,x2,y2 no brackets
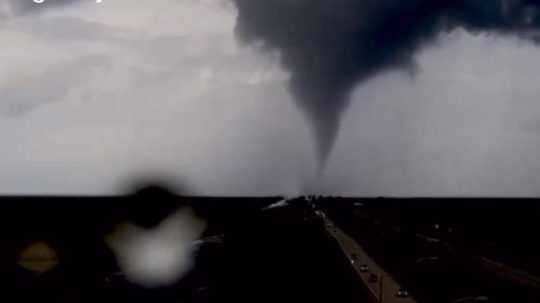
233,0,540,162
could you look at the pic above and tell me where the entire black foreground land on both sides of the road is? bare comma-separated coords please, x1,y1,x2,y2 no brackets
0,190,540,303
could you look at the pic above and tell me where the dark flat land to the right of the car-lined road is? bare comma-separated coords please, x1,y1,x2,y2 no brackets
318,199,540,303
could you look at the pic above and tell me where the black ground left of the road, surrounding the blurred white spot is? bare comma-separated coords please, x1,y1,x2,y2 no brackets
0,195,368,303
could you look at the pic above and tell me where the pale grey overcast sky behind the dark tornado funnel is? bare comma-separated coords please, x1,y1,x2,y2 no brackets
0,0,540,196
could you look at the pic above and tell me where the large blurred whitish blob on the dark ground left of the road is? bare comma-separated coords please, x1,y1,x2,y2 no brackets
106,208,206,287
